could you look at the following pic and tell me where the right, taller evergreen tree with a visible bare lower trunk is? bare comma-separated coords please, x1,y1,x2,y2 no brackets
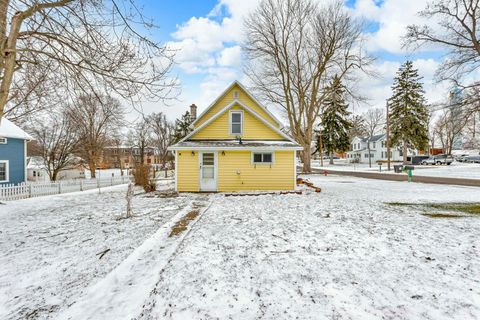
388,61,429,164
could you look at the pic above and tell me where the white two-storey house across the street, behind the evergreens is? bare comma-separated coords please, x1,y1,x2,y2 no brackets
347,133,418,163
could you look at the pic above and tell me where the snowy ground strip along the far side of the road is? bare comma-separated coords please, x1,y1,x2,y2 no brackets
312,159,480,179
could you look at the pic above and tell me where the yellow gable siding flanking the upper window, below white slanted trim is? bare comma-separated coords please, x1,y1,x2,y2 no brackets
190,106,284,140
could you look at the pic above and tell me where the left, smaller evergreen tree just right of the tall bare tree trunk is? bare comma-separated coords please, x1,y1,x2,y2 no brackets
320,76,352,164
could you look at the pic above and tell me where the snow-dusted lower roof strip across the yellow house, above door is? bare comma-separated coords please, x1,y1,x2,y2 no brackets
171,139,303,150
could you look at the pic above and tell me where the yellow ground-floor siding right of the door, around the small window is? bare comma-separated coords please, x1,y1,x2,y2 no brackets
218,151,295,191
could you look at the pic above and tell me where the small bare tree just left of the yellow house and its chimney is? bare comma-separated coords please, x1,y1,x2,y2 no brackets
147,112,175,170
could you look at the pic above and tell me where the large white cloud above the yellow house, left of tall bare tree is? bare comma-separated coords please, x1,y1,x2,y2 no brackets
162,0,258,116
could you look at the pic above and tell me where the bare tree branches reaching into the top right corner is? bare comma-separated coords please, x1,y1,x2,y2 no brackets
404,0,480,107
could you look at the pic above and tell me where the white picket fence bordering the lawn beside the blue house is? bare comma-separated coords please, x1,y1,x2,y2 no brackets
0,176,130,201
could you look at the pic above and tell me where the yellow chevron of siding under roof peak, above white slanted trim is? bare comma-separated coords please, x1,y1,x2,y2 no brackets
195,84,279,128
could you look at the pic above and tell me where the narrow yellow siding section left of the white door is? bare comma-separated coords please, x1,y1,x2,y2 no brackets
176,150,199,192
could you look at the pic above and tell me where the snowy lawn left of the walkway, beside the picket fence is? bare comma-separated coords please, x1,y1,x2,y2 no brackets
0,181,197,320
